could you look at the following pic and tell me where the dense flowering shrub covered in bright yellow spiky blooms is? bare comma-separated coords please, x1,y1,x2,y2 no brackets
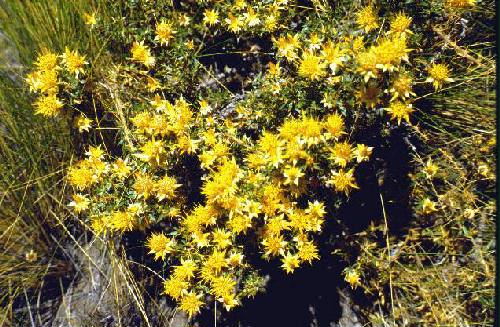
23,0,484,322
